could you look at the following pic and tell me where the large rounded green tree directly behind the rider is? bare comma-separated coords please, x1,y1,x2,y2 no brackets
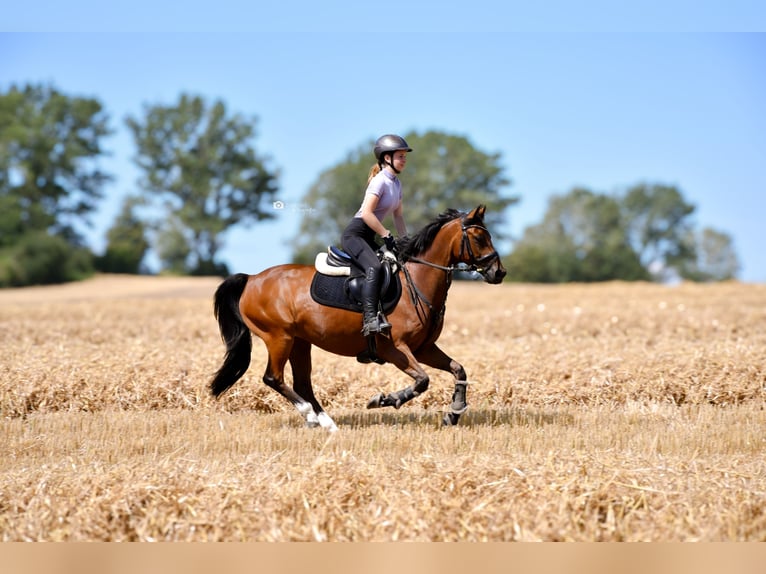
292,131,518,263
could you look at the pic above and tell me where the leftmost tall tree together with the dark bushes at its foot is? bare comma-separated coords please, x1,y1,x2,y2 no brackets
0,85,111,286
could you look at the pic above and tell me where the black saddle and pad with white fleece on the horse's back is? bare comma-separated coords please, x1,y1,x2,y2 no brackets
311,246,402,314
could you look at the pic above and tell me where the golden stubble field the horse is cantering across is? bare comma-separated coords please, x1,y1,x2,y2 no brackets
0,276,766,541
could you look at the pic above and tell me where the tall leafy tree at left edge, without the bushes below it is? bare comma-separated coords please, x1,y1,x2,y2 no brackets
0,85,111,246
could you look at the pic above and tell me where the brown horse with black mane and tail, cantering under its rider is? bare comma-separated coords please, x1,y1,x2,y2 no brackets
210,205,505,431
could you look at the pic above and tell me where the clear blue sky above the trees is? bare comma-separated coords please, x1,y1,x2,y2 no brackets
0,4,766,282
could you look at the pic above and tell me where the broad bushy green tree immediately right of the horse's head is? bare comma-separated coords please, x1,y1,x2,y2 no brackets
507,188,648,283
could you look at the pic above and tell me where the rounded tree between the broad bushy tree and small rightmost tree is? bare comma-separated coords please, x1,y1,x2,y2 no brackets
621,183,695,282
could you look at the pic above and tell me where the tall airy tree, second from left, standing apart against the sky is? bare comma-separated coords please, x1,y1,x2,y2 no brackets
126,94,277,274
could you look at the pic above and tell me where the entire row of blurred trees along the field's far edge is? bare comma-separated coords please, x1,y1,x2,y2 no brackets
0,84,739,287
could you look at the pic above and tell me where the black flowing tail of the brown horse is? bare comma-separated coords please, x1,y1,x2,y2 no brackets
210,273,253,397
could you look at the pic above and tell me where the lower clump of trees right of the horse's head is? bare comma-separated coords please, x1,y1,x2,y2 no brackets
507,183,740,283
